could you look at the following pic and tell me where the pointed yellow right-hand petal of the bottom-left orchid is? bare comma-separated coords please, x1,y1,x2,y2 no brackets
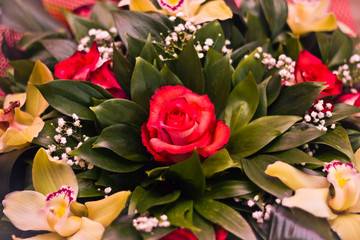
85,191,131,227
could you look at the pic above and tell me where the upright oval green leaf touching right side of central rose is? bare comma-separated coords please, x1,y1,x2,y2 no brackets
225,73,259,131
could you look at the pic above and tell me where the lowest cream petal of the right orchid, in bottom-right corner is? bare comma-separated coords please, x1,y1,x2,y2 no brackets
329,214,360,240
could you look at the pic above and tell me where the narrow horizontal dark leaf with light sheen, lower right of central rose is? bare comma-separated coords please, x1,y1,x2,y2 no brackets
204,180,258,199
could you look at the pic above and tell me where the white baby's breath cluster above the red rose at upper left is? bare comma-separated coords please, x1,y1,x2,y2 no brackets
77,27,122,65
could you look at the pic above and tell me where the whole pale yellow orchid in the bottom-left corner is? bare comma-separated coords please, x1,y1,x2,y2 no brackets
2,148,130,240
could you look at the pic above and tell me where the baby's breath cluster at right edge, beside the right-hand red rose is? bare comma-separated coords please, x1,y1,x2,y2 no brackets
333,54,360,87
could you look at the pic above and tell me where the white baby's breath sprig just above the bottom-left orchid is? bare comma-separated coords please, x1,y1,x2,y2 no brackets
46,113,94,169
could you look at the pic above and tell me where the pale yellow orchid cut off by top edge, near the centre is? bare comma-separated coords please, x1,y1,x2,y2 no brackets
120,0,232,24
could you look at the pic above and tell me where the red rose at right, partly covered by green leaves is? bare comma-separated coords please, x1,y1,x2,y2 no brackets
295,50,342,99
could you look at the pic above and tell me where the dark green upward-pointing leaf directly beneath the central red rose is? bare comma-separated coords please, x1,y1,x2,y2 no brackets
165,150,205,197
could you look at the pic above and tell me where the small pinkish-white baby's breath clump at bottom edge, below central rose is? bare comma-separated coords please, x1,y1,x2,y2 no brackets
133,214,171,233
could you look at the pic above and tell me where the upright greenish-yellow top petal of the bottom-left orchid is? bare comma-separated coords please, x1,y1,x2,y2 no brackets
32,148,79,198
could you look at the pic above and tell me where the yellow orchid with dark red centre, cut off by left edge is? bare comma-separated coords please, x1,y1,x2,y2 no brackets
0,61,53,153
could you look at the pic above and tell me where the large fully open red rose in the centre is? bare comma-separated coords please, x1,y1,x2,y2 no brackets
141,86,230,163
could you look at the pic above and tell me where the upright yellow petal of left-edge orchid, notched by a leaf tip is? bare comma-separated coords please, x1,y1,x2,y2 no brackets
25,61,54,117
